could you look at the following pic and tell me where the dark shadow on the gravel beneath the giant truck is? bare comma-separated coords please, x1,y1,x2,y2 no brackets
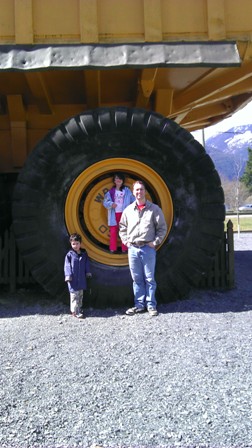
0,251,252,321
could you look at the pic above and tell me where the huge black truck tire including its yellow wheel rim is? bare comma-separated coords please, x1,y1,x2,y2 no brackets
13,107,225,306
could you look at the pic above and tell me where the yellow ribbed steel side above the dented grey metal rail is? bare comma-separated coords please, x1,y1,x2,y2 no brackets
0,0,251,44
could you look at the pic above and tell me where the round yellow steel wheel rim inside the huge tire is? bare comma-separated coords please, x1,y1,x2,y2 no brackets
65,158,173,266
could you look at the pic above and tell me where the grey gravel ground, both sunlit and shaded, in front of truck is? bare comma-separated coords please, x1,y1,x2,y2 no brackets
0,234,252,448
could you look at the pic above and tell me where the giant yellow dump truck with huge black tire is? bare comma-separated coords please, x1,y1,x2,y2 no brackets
0,0,252,305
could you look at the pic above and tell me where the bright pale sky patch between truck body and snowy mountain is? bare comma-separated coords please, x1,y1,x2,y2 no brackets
192,101,252,143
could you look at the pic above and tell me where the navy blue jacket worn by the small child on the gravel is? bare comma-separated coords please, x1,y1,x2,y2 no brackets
64,249,90,292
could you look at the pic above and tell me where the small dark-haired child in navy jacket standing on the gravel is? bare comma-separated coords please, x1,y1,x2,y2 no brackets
64,233,92,319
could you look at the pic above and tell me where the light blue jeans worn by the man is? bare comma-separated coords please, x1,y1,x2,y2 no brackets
128,245,157,309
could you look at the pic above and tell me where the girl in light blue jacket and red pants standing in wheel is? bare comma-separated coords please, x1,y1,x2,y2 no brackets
103,173,136,254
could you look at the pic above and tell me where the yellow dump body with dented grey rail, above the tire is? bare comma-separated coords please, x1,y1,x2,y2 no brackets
0,0,252,172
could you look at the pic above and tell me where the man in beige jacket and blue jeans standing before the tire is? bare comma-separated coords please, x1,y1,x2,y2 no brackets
119,180,167,316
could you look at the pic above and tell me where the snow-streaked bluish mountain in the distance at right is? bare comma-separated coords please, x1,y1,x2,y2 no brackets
205,124,252,179
